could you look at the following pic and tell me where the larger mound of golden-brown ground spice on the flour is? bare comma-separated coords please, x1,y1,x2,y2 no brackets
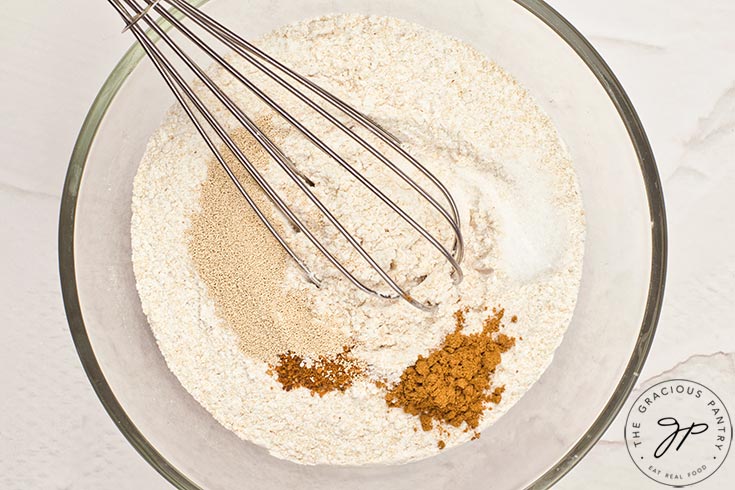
385,309,515,431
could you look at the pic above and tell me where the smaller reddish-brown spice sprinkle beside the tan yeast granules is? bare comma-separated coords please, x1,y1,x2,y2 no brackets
271,347,361,396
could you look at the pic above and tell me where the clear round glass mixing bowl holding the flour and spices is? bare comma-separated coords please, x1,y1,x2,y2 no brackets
59,0,666,490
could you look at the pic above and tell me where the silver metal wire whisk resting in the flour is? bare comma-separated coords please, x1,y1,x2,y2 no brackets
108,0,464,311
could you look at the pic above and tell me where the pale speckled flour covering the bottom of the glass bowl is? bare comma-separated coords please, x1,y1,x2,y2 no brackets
132,15,584,464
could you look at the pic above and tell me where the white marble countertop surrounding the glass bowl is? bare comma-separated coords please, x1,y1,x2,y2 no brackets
0,0,735,490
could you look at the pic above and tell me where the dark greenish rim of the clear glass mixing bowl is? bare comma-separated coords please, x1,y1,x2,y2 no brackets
58,0,668,490
